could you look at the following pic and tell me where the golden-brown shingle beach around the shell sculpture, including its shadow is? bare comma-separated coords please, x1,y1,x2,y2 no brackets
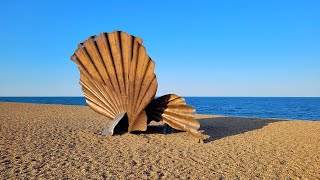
0,103,320,179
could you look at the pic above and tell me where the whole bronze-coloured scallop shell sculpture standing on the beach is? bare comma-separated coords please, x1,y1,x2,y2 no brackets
71,31,208,142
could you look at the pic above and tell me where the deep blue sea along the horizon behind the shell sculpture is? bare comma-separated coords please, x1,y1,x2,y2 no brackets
0,97,320,121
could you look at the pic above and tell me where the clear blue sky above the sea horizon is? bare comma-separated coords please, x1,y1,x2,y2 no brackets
0,0,320,96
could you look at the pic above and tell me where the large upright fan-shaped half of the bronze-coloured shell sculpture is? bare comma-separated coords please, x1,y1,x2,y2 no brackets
71,31,158,132
